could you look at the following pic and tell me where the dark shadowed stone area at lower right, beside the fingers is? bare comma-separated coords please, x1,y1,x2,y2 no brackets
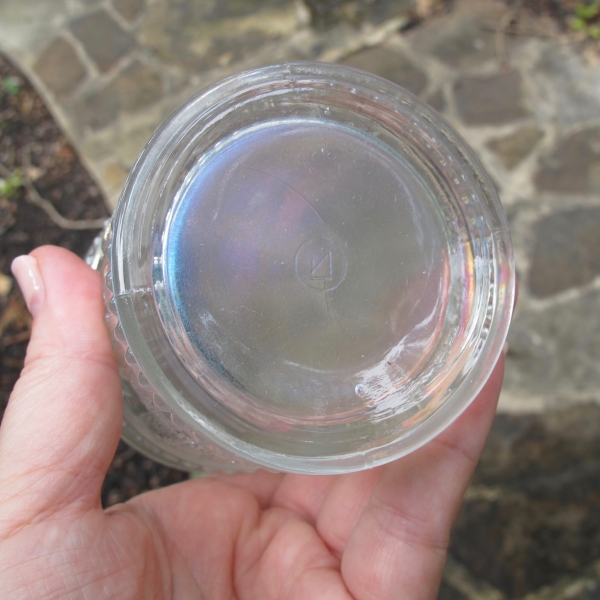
450,404,600,598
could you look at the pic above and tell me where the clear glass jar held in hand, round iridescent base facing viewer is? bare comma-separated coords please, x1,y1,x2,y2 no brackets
91,63,514,473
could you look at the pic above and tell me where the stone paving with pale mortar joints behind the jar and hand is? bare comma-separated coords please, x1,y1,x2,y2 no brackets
0,0,600,600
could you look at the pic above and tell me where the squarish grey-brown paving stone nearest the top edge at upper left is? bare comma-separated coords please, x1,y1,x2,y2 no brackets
71,10,135,72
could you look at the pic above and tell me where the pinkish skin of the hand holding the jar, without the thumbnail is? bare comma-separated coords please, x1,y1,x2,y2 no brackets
0,247,503,600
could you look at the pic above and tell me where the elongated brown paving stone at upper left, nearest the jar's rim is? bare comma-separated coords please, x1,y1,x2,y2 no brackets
73,61,163,130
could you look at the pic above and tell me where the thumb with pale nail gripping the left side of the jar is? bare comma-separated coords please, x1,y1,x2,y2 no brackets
0,246,122,525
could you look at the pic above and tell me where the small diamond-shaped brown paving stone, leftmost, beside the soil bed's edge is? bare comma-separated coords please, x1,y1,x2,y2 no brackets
33,38,87,97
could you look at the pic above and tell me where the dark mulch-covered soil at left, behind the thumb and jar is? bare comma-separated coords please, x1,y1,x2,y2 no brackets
0,57,187,506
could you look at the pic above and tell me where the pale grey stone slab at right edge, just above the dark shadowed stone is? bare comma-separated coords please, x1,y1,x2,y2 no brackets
504,290,600,404
